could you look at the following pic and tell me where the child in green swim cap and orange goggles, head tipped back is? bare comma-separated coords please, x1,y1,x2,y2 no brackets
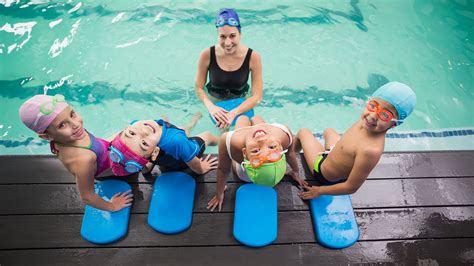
207,116,306,211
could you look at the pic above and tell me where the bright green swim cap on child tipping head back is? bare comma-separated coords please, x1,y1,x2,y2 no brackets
243,154,286,187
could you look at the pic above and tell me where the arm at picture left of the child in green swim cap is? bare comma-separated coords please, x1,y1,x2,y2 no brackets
207,133,232,211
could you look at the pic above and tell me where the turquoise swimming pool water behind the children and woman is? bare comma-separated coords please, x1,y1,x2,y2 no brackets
0,0,474,155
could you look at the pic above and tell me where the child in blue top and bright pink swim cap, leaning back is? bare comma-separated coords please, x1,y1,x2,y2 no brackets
109,119,218,176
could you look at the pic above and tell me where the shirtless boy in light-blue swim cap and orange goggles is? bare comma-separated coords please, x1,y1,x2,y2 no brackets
295,82,416,199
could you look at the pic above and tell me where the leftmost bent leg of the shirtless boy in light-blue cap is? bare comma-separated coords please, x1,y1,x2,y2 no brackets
294,128,324,169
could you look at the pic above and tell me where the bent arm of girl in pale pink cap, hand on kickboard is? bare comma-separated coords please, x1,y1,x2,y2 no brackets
68,156,133,211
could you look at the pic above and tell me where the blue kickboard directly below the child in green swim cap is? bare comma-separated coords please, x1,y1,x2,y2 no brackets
233,184,278,247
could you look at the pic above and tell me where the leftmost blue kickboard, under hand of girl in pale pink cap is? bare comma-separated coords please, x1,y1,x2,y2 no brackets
81,180,131,244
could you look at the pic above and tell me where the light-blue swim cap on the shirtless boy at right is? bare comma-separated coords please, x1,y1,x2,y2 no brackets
372,81,416,125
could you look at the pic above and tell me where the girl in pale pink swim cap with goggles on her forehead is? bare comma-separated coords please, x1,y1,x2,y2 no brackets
19,94,133,211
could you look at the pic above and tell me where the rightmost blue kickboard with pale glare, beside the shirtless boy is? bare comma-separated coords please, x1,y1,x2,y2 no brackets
310,195,359,249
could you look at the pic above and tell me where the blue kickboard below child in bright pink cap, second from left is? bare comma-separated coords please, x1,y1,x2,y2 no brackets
148,172,196,234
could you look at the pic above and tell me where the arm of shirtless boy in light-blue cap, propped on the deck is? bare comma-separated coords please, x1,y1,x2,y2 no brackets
300,149,382,199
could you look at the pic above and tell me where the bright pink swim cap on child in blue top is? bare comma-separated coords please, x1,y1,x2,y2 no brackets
109,133,149,176
